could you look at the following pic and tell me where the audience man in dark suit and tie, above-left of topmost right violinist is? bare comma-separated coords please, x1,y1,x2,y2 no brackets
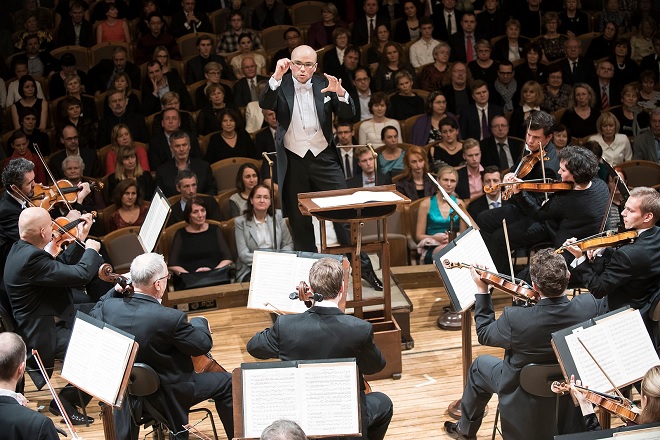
460,80,504,140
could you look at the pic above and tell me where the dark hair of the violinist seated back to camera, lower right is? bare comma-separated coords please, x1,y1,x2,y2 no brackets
529,249,568,298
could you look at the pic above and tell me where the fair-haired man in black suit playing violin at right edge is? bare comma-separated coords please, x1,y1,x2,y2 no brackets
566,187,660,326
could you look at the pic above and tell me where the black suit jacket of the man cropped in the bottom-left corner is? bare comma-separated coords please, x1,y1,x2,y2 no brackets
0,398,59,440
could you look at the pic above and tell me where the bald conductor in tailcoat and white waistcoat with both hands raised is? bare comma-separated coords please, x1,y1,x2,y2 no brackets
259,43,382,289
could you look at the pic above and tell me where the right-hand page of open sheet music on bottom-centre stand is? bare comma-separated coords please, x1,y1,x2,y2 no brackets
298,362,360,435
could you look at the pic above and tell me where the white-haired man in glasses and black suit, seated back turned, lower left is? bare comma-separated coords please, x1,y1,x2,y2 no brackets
90,253,234,439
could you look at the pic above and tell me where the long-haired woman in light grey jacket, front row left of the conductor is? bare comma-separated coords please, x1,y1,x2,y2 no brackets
234,184,293,282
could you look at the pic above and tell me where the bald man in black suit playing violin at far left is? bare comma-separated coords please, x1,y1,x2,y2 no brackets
4,208,103,425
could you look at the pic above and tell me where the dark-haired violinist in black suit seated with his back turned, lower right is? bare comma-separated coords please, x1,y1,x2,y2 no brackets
445,249,599,440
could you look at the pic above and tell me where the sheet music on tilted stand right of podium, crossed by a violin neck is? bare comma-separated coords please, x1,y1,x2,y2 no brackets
442,229,495,310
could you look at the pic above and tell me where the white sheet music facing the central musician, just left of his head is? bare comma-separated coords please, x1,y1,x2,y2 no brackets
247,251,316,313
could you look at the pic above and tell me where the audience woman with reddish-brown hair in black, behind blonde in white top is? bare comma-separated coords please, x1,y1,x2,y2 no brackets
561,83,600,138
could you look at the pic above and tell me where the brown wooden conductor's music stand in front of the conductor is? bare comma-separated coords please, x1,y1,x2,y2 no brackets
298,185,410,380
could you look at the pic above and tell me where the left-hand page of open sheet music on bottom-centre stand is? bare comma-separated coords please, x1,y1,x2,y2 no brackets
242,367,304,438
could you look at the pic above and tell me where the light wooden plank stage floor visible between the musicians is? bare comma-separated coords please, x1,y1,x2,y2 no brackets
27,270,510,440
